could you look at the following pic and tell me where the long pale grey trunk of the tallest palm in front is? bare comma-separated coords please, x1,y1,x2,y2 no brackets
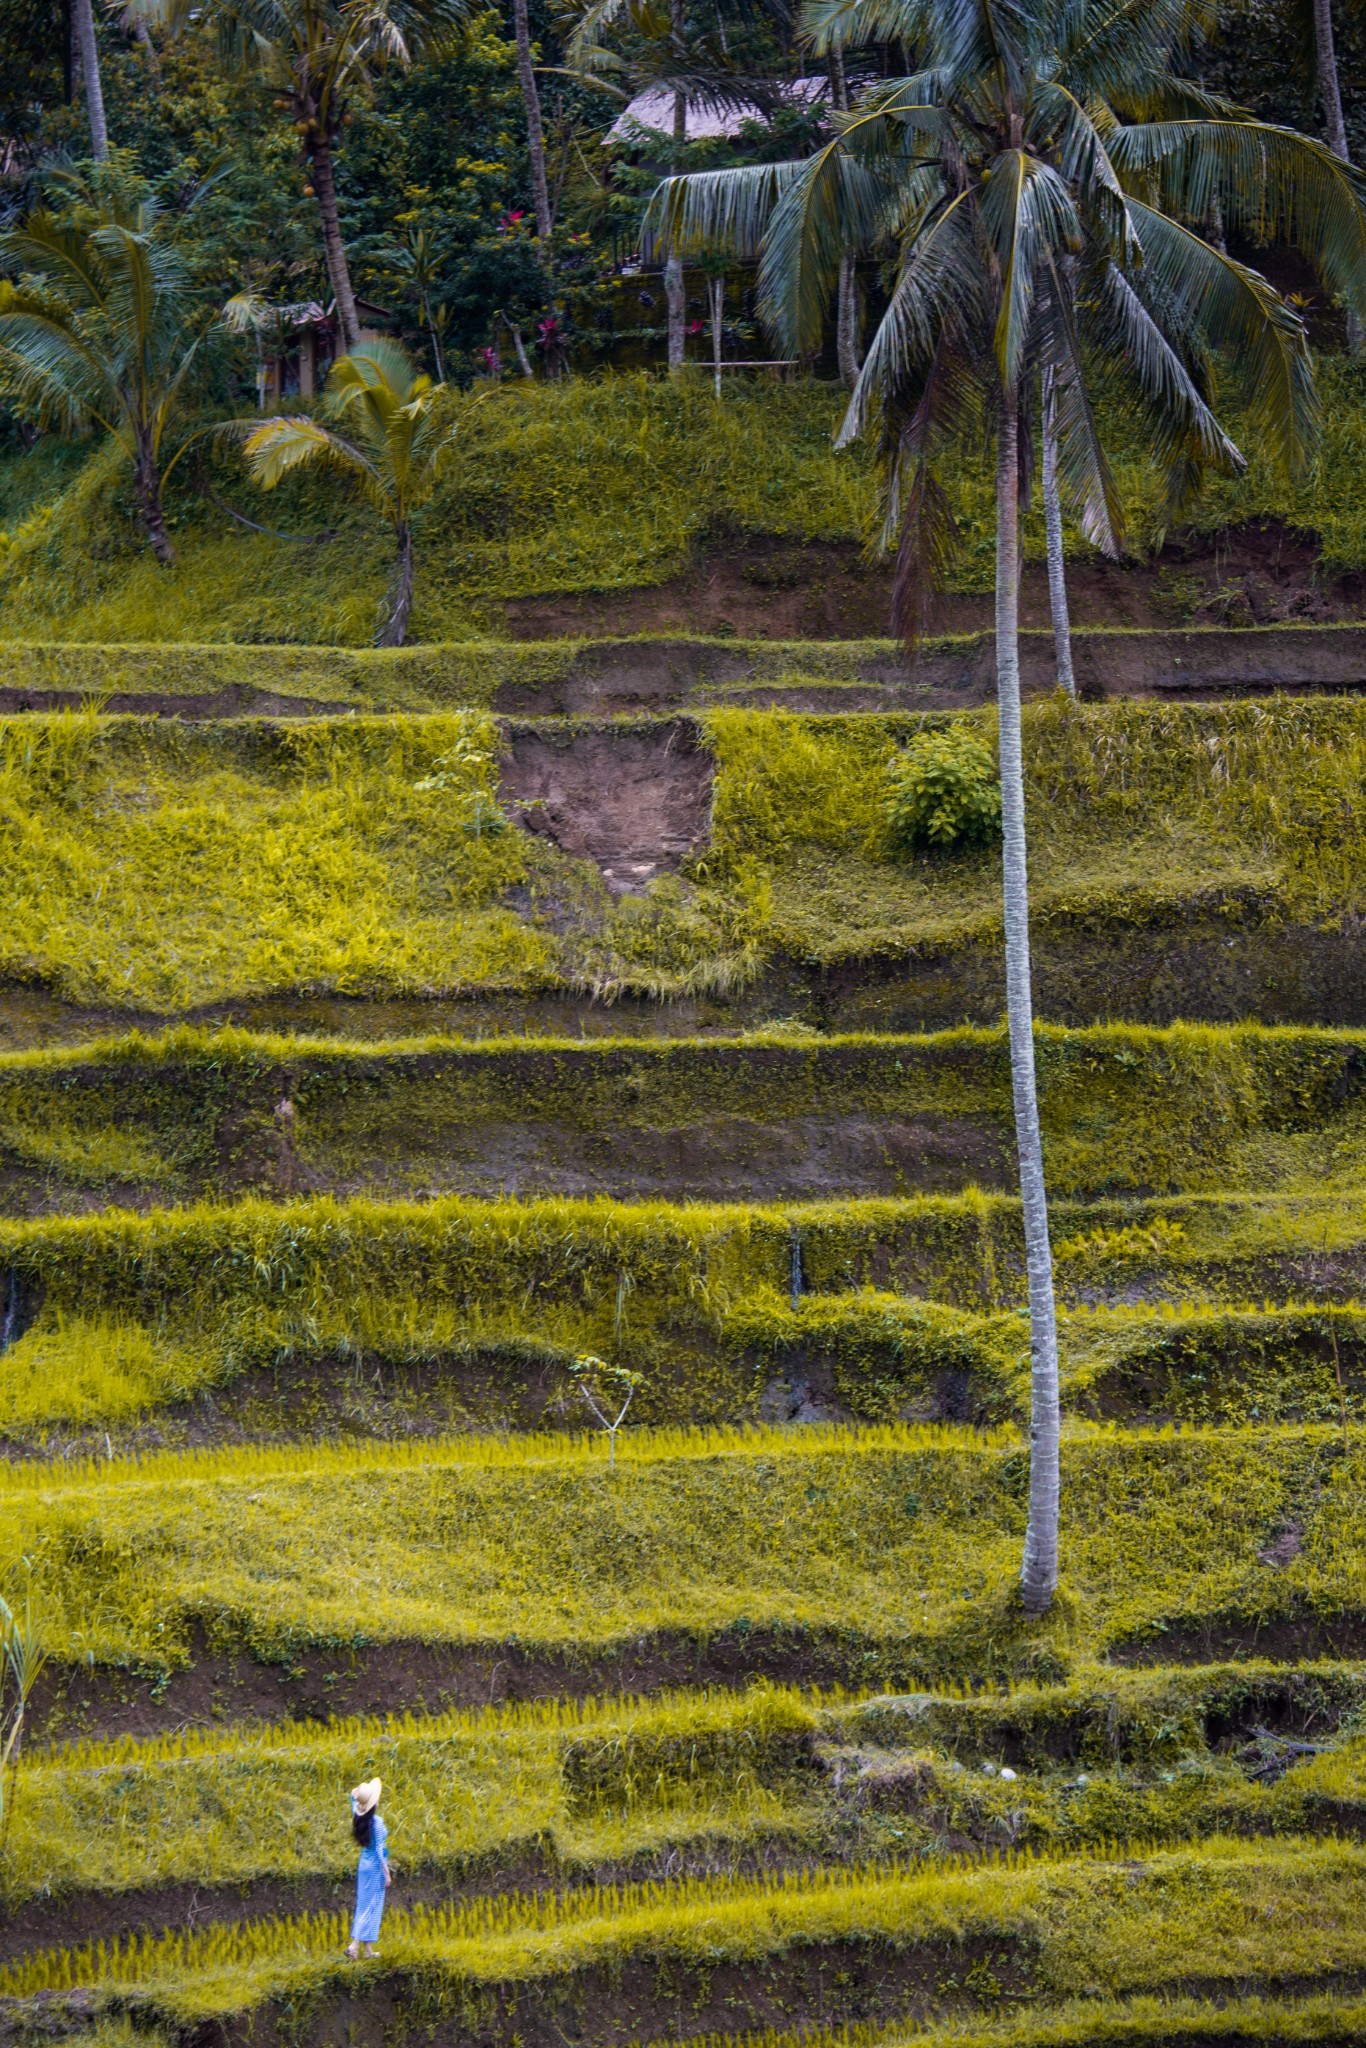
995,376,1061,1614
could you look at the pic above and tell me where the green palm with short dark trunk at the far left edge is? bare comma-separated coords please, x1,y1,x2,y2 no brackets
0,162,252,567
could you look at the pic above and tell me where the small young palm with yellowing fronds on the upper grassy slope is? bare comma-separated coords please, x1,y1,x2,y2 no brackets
246,342,459,647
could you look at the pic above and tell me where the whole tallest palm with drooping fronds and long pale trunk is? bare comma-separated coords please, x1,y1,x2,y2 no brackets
653,0,1366,1612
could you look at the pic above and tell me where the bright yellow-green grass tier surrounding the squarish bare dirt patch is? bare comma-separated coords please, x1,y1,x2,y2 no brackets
0,698,1366,1014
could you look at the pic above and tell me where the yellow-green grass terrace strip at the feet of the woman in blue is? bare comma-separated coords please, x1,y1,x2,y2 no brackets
0,1839,1366,2021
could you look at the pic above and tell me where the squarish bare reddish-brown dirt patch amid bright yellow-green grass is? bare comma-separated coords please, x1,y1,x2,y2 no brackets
502,719,715,895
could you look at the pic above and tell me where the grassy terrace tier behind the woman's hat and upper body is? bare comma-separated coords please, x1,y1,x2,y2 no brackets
4,1661,1366,1903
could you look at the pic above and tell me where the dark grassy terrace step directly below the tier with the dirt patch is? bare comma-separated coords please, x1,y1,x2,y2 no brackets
13,1024,1366,1206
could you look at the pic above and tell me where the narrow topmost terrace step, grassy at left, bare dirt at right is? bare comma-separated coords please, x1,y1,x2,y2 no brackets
0,623,1366,717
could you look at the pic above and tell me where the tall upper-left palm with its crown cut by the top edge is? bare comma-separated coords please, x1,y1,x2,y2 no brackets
137,0,465,350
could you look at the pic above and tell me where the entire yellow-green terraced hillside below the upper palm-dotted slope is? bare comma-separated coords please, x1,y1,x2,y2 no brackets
0,629,1366,2048
